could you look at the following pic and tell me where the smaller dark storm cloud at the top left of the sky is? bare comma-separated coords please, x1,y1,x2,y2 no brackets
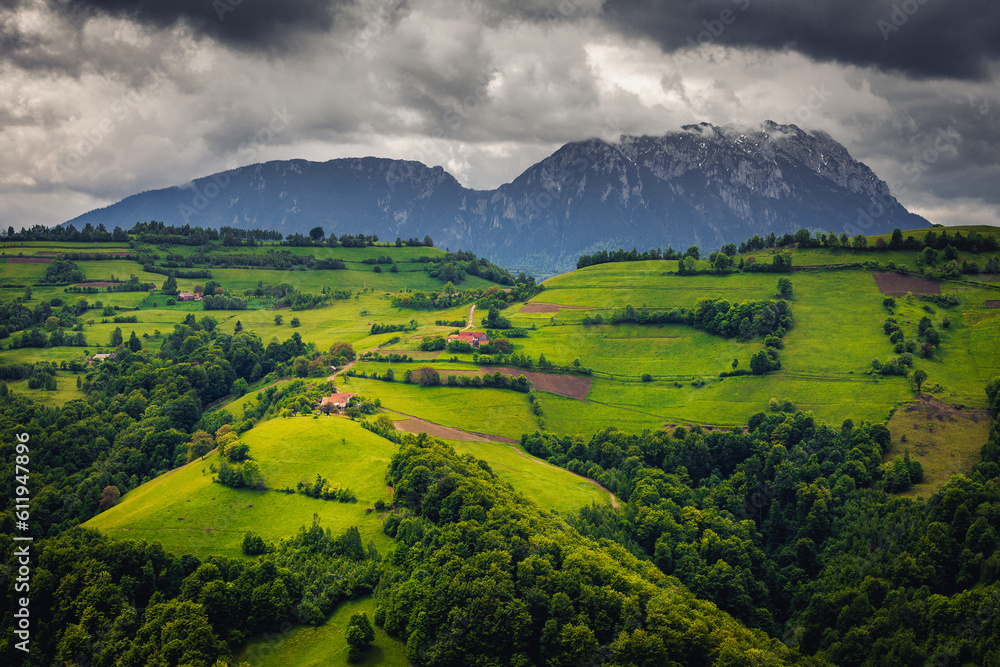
50,0,350,49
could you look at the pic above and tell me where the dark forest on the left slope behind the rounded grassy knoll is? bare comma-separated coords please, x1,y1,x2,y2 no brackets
0,314,320,537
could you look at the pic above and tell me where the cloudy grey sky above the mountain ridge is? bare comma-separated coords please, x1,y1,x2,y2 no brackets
0,0,1000,228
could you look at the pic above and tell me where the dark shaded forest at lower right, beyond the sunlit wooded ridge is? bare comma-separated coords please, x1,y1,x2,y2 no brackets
522,378,1000,666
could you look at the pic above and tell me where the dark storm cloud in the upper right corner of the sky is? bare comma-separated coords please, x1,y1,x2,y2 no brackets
604,0,1000,79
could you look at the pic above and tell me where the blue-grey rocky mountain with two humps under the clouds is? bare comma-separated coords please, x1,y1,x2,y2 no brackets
67,121,930,274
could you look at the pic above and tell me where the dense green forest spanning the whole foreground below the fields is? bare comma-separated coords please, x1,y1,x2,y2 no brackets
2,379,1000,666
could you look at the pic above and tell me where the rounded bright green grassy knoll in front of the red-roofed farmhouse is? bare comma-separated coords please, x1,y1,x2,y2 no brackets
86,417,396,557
